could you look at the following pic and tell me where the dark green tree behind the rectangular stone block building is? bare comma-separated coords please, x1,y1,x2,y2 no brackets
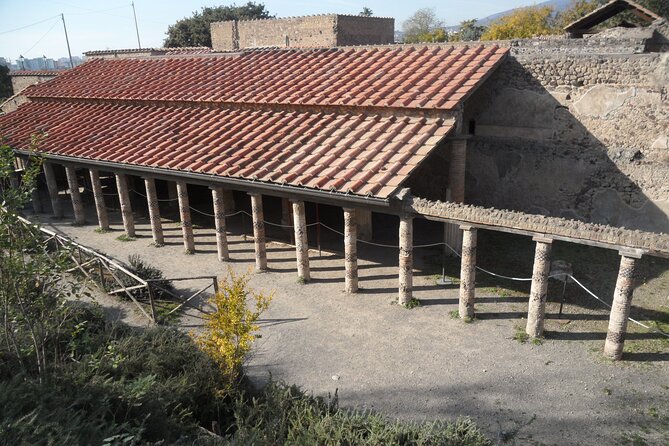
163,2,273,48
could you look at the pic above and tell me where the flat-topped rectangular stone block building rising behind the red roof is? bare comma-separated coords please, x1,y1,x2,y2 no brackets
211,14,395,51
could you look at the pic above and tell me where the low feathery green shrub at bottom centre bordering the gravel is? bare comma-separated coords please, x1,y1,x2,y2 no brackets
228,383,492,446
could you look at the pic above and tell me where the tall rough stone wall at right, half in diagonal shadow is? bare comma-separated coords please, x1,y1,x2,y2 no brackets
464,46,669,233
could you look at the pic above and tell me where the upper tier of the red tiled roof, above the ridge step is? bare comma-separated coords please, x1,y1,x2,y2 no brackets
26,45,508,110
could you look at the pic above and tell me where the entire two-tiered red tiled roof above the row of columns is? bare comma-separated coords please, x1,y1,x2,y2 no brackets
0,45,507,199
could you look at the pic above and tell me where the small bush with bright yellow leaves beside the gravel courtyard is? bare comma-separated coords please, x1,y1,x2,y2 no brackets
194,270,274,391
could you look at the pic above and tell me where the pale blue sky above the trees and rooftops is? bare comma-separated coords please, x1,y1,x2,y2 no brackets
0,0,536,61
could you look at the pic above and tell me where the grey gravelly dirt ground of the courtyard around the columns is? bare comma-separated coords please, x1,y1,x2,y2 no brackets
32,197,669,445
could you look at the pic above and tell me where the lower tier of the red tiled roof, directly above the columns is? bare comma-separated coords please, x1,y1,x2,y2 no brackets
0,101,452,198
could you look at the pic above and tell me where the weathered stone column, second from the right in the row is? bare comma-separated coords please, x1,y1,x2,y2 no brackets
525,237,553,338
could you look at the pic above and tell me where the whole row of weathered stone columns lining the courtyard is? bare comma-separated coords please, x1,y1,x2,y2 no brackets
34,162,639,359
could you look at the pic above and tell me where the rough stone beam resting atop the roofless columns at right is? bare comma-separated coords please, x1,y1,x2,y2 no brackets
404,197,669,257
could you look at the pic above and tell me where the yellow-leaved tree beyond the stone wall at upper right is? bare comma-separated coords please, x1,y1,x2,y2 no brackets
481,6,557,40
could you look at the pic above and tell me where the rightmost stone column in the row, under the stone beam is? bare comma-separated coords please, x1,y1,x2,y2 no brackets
604,253,637,360
